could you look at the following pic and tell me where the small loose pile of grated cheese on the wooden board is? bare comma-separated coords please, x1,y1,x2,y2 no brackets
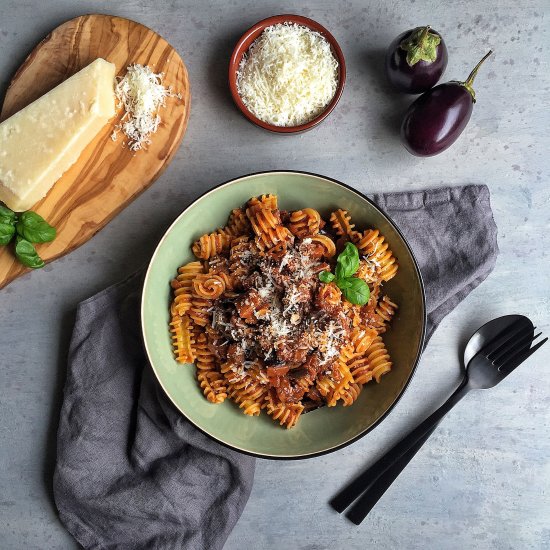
111,63,181,151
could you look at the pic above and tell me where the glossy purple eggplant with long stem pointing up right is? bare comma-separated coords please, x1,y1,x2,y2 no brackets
401,51,493,157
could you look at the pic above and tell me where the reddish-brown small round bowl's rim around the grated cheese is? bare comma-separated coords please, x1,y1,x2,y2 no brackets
229,13,346,134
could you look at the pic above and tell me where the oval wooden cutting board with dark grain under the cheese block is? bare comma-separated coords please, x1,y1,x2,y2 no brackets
0,15,191,288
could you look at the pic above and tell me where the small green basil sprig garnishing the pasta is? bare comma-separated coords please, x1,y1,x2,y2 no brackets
319,243,370,306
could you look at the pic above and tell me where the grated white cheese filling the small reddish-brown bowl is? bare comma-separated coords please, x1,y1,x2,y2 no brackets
237,23,338,126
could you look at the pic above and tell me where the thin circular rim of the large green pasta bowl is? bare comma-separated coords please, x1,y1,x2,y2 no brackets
140,170,427,460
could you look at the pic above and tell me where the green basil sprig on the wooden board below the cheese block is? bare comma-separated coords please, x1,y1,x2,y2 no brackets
0,204,56,269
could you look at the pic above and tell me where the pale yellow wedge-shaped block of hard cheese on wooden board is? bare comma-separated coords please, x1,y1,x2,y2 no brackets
0,59,115,211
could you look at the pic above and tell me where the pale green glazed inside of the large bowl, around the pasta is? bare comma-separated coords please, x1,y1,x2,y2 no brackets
141,172,426,459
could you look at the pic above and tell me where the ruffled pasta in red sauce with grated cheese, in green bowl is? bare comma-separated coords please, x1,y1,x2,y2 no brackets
169,195,398,428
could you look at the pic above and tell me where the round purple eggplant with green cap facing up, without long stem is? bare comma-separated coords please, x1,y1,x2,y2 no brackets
386,26,447,94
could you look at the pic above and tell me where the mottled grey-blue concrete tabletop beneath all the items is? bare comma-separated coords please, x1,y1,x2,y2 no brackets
0,0,550,550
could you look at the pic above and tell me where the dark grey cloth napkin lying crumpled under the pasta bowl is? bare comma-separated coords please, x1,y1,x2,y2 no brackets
54,185,498,550
